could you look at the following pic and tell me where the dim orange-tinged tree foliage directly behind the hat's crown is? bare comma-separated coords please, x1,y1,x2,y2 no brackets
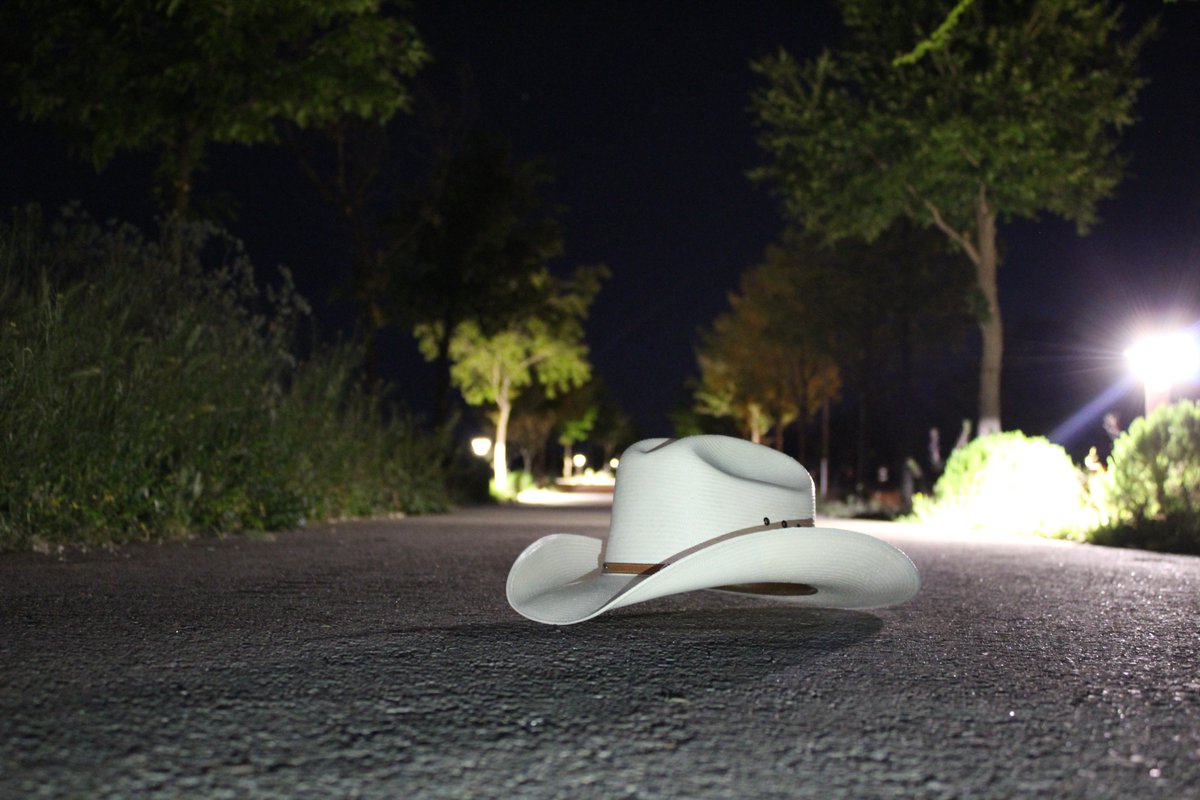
695,224,971,450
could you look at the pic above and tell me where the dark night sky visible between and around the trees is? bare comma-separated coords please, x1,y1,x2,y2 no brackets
0,0,1200,462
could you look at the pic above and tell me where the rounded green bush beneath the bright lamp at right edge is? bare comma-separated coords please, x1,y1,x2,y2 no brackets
1090,401,1200,553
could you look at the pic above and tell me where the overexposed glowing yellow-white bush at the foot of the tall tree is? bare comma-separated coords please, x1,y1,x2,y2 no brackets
913,431,1090,537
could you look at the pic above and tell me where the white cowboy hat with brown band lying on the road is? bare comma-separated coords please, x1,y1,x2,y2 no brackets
508,435,920,625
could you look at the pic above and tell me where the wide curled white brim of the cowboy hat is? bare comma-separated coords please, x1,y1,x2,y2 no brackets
506,528,920,625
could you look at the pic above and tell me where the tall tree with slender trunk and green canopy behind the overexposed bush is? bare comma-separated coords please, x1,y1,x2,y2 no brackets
752,0,1152,433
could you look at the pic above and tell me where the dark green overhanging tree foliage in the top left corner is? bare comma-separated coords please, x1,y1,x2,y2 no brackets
0,0,428,210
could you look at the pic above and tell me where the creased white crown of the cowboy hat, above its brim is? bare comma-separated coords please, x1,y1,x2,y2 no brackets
604,435,815,564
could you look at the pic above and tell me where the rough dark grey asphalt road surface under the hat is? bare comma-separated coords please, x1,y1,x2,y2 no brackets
0,509,1200,800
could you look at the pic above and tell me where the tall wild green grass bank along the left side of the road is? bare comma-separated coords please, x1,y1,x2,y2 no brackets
0,210,448,549
